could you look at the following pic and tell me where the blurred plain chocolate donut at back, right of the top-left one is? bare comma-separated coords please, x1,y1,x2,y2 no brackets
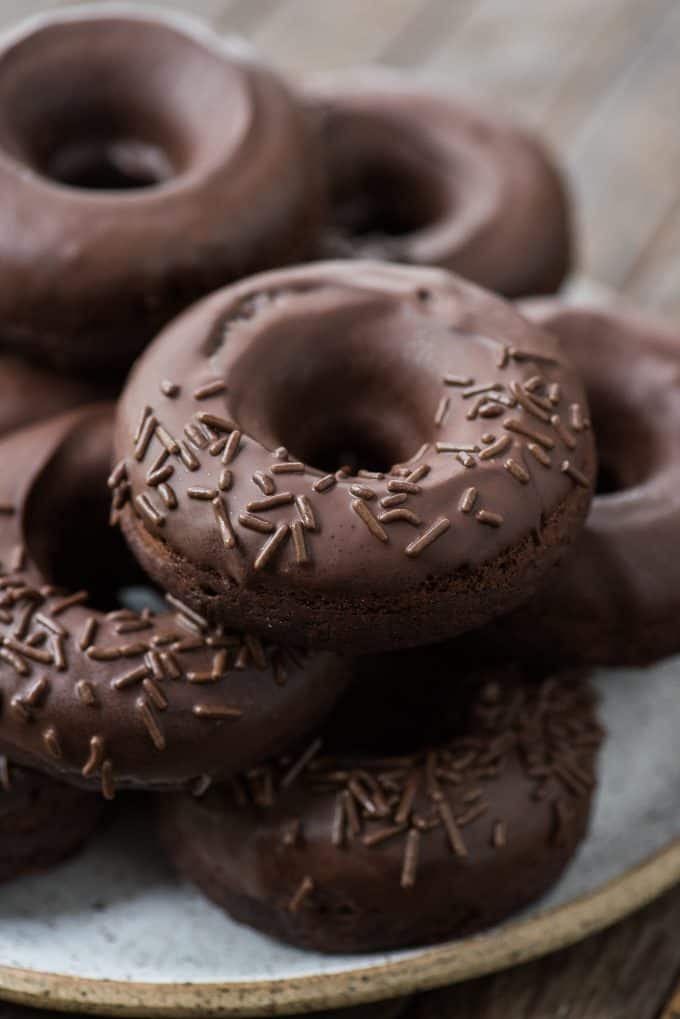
304,70,571,297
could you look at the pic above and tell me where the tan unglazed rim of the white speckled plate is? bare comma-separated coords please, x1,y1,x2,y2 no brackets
0,839,680,1019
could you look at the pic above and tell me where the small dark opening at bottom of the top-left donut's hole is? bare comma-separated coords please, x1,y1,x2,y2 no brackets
44,139,173,191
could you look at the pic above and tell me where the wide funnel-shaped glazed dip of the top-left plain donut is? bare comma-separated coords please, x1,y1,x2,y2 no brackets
0,16,248,193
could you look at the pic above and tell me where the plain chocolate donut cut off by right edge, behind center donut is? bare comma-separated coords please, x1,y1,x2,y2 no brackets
483,301,680,665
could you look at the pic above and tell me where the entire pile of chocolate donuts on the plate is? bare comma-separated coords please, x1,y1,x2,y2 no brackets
0,7,680,952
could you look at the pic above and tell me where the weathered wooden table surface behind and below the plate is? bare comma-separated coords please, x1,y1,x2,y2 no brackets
0,0,680,1019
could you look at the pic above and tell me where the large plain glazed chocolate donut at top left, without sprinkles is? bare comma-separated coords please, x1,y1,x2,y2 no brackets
0,5,322,371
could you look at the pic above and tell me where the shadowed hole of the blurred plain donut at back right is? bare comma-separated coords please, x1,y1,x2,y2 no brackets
327,112,450,243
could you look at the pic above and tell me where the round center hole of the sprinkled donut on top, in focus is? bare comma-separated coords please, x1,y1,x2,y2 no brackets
229,309,439,474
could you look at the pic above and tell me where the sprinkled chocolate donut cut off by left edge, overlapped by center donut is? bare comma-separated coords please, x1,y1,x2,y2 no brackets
0,405,347,798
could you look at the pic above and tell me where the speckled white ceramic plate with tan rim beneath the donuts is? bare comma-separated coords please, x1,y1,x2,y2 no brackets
0,644,680,1016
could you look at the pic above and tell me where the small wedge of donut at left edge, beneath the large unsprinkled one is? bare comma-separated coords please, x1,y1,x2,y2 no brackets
0,353,111,436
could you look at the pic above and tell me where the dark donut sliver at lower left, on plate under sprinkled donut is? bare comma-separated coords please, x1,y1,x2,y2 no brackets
0,757,103,881
